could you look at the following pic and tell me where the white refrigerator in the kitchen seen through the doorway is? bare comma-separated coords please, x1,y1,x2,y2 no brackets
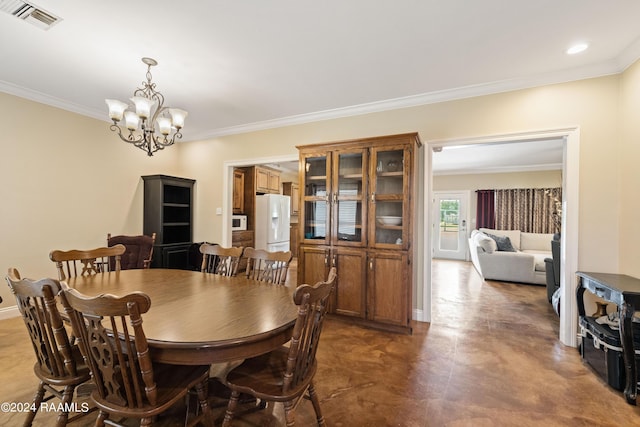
255,194,291,252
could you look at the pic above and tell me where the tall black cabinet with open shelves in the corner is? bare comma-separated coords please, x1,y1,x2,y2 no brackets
142,175,195,270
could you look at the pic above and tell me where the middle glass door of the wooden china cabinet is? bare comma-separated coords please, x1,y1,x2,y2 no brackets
332,150,367,246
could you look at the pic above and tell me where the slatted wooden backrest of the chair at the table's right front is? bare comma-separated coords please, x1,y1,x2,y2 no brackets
282,267,337,394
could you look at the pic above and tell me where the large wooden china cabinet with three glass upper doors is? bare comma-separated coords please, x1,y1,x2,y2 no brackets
297,133,421,333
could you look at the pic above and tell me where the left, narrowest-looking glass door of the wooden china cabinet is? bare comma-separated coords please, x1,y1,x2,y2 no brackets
302,154,330,243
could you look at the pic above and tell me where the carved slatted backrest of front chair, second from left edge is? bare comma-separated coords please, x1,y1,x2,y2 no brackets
61,285,157,409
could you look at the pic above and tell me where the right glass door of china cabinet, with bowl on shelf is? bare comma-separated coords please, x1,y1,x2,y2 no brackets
369,147,408,249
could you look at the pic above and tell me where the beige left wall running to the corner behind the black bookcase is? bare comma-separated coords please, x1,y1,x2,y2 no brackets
0,93,178,307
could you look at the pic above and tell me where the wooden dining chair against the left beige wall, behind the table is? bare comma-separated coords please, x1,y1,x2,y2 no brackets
49,245,126,280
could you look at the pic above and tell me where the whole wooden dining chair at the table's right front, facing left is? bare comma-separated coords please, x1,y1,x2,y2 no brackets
222,267,336,427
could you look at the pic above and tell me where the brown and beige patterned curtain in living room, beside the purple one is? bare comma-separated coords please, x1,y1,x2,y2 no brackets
495,188,562,233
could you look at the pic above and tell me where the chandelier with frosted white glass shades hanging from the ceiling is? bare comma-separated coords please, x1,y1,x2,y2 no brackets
105,58,187,156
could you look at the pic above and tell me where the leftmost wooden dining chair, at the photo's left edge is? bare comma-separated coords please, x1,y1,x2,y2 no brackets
6,268,91,426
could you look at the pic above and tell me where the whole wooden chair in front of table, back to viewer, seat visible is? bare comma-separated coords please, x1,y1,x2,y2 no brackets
60,283,213,426
